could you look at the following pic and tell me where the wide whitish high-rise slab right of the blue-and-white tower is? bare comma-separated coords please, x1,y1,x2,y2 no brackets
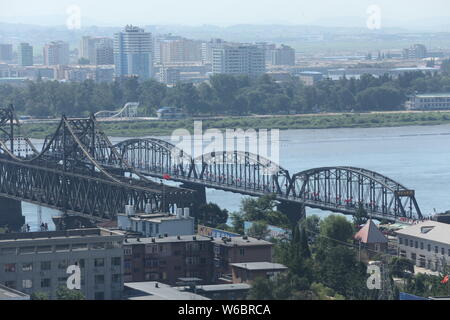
212,44,266,77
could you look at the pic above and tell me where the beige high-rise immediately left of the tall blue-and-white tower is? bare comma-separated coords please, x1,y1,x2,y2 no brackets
80,36,114,65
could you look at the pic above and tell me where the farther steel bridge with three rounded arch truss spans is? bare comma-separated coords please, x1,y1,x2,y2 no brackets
110,139,423,222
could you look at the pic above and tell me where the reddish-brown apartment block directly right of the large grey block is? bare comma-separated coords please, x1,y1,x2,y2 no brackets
124,235,213,285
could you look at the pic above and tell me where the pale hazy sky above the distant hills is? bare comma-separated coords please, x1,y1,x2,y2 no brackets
0,0,450,25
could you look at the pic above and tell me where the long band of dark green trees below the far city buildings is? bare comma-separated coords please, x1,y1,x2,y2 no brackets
0,66,450,116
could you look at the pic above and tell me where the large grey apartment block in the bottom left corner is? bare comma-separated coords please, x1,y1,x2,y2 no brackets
0,229,124,300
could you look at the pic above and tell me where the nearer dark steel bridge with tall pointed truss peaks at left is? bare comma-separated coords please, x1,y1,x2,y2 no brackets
0,106,194,221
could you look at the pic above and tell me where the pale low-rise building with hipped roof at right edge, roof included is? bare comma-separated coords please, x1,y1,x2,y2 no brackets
397,220,450,271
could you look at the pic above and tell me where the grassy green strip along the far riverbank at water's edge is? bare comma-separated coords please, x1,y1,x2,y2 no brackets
22,110,450,139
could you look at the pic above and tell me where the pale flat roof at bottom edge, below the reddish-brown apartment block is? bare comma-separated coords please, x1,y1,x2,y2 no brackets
124,281,210,300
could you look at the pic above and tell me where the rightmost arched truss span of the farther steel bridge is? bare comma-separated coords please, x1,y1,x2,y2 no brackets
286,167,423,221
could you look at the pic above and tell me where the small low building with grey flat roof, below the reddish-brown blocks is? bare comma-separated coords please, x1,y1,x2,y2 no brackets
231,262,288,283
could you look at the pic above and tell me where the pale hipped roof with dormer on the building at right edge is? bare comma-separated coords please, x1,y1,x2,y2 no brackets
397,220,450,244
